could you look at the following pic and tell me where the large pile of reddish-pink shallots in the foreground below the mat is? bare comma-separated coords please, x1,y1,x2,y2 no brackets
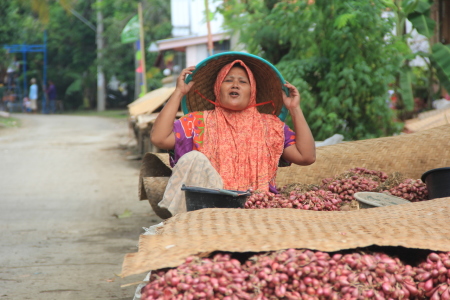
141,249,450,300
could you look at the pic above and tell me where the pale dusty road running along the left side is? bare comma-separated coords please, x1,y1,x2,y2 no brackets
0,115,161,300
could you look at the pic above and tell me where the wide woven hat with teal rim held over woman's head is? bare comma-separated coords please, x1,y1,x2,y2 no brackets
181,52,289,121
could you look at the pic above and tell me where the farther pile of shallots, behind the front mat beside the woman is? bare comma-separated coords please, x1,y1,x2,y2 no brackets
244,168,428,211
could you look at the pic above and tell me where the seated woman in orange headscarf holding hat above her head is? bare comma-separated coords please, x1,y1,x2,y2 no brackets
151,54,315,215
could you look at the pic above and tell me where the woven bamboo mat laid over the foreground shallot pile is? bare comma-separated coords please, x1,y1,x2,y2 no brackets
121,197,450,277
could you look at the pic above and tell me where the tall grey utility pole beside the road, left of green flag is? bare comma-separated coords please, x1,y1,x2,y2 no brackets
96,0,106,111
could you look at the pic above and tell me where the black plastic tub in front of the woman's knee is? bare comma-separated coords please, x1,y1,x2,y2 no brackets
181,184,250,211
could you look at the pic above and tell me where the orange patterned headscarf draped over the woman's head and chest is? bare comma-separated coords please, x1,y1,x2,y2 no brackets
199,60,284,191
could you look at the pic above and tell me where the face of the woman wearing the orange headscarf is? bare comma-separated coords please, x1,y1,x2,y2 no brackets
220,67,250,110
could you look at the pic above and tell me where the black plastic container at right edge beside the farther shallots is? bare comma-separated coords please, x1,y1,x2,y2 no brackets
422,167,450,200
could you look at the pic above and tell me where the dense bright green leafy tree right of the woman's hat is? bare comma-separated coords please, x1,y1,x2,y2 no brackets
222,0,401,140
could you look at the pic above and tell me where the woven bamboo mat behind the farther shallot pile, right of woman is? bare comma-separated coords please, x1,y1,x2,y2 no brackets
277,125,450,187
